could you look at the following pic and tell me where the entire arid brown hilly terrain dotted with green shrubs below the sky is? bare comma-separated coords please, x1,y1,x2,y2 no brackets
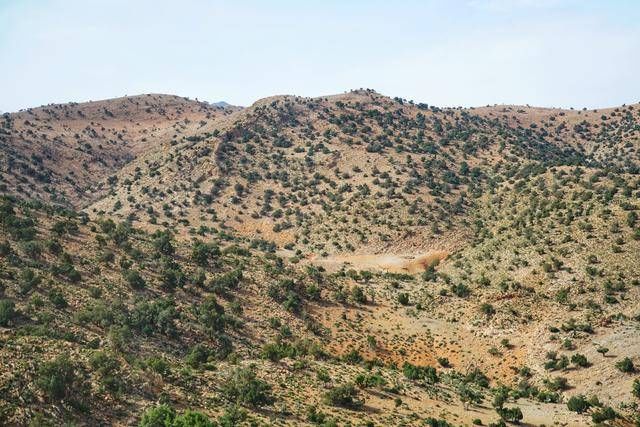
0,90,640,426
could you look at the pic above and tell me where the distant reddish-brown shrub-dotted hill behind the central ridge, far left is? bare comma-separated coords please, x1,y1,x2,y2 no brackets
0,95,237,207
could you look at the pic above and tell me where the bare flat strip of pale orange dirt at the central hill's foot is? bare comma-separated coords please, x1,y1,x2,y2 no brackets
309,251,448,274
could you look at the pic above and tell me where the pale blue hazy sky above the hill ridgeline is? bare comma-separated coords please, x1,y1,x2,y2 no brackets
0,0,640,112
